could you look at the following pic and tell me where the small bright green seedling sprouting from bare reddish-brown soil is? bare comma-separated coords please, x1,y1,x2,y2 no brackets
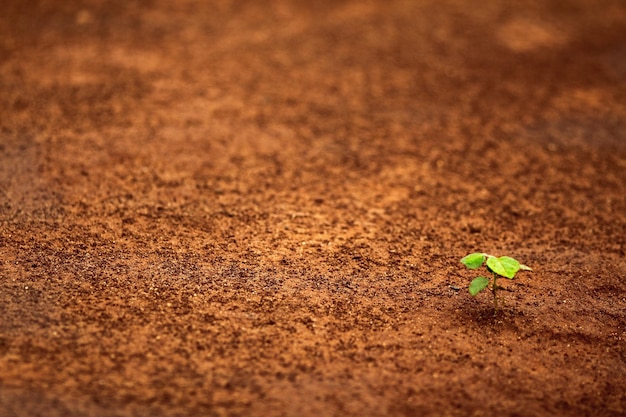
461,253,532,315
